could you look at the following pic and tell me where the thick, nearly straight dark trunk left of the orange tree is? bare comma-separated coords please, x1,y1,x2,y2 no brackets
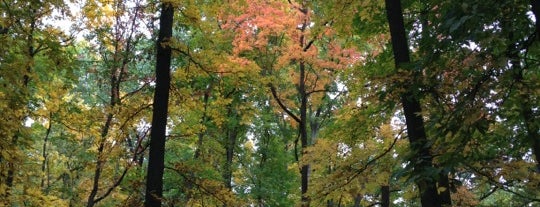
144,2,174,207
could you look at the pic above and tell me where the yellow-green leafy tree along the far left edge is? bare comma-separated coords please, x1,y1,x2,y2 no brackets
0,1,70,205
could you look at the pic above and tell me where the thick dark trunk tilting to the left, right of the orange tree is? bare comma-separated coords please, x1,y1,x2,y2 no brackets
385,0,450,207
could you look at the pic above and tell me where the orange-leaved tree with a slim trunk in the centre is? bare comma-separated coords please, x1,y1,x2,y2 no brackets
225,1,358,206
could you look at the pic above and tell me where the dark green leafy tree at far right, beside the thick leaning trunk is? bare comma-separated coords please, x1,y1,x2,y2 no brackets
416,1,537,203
